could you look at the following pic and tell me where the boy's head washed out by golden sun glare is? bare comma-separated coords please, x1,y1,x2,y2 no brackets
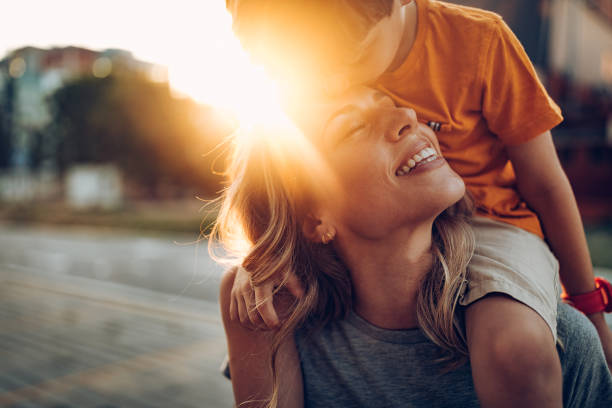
226,0,411,94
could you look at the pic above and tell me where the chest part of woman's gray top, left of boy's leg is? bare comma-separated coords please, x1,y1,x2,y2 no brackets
296,313,479,408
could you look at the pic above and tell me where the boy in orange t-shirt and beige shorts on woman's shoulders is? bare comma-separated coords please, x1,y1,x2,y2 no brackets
228,0,612,407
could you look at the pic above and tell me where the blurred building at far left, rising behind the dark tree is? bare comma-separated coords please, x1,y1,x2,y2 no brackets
0,47,167,170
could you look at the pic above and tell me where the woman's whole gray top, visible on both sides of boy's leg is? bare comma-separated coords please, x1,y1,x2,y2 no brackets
295,304,612,408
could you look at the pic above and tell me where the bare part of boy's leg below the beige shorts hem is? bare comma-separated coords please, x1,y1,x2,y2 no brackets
465,294,563,408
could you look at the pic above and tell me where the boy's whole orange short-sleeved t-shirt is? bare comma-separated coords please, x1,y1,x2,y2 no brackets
378,0,563,237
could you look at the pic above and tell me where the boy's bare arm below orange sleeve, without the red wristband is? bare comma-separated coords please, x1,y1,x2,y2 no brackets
506,132,612,367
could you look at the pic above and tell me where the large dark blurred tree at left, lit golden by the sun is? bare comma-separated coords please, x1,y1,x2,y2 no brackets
48,74,232,197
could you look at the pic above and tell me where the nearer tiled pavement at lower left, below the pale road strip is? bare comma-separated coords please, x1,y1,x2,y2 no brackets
0,267,233,408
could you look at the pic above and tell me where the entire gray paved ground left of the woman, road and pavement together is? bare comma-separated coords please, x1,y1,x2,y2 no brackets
0,226,232,408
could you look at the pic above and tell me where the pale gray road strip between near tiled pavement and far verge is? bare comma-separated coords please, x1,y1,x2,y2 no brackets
0,224,226,301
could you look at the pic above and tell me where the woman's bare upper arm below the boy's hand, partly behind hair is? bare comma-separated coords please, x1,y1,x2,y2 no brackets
219,268,304,408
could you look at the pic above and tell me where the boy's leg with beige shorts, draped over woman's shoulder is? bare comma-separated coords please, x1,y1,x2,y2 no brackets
460,217,563,408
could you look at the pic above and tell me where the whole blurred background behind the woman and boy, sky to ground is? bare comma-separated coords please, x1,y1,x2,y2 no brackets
0,0,612,407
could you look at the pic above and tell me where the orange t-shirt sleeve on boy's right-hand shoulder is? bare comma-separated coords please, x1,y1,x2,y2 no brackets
481,19,563,145
